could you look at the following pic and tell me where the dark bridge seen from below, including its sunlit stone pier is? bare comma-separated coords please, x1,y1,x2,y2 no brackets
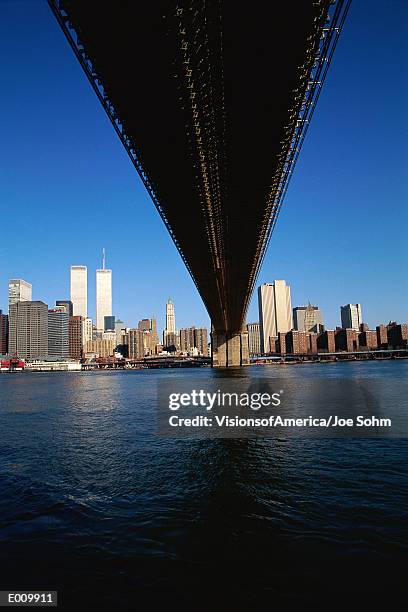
49,0,350,366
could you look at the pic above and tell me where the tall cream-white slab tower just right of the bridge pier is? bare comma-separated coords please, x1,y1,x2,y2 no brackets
258,280,293,353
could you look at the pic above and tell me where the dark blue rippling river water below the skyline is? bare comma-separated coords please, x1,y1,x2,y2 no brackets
0,360,408,611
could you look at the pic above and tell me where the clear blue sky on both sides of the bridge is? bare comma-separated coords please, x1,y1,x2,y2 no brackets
0,0,408,328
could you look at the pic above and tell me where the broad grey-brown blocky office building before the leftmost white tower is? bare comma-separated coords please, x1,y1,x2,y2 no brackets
9,301,48,359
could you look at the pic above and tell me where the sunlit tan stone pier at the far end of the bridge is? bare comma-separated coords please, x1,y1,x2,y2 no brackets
211,329,249,368
